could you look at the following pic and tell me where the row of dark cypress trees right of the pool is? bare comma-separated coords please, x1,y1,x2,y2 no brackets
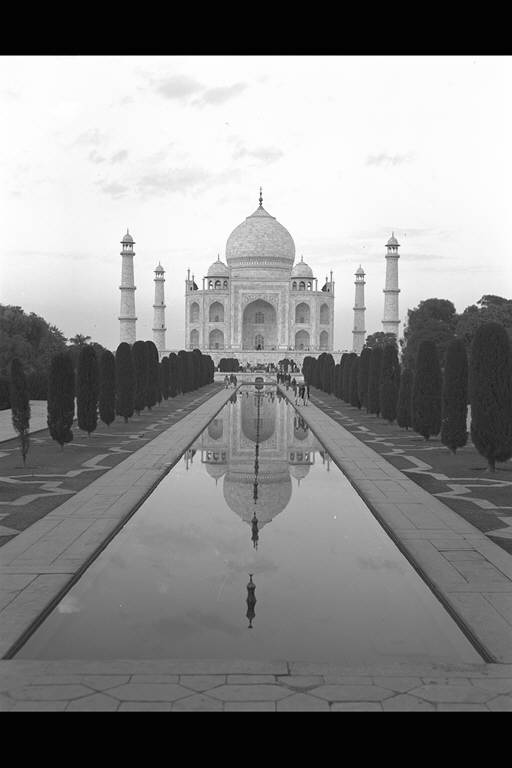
302,321,512,472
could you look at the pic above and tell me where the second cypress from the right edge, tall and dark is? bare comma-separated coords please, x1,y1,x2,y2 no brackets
441,339,468,453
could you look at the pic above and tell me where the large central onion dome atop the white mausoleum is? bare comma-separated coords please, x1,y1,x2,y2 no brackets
226,202,295,270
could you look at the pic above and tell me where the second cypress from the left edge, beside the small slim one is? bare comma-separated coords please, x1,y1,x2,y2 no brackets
47,352,75,449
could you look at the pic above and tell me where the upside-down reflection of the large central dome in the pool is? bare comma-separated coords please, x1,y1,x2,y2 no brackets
224,468,292,529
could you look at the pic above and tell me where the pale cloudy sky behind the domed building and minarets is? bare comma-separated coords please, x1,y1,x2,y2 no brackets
0,56,512,349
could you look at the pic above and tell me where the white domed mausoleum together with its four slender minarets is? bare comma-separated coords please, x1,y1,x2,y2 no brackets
119,188,400,365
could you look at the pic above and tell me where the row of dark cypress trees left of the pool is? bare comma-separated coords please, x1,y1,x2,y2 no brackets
9,341,215,463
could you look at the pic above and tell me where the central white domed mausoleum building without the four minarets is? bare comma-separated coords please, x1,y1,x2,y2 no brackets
185,190,334,363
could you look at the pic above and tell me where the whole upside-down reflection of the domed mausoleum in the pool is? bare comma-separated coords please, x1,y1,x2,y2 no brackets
189,389,329,546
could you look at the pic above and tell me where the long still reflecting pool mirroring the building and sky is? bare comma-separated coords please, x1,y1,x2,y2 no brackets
17,387,481,664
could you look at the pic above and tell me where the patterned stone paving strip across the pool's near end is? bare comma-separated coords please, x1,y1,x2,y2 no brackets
0,660,512,712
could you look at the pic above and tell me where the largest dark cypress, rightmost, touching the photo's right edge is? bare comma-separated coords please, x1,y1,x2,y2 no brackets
469,323,512,472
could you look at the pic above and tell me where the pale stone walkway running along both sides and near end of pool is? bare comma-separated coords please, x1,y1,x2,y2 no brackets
0,380,512,712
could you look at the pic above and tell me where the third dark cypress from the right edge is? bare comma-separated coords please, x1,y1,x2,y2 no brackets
412,340,442,440
